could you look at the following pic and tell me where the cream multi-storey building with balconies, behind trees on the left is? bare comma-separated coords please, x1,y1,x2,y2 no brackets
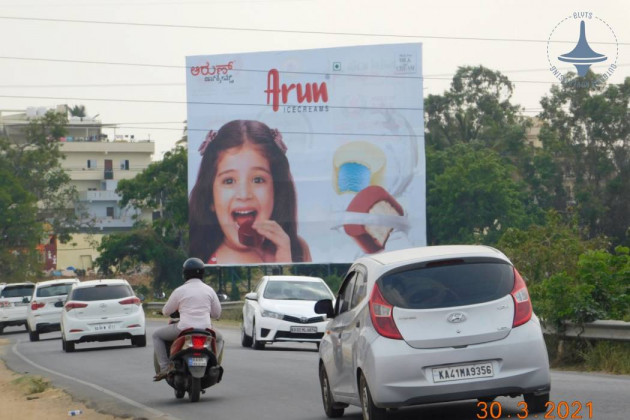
0,105,155,270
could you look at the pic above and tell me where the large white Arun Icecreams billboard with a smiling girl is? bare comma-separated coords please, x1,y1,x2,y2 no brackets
186,43,426,265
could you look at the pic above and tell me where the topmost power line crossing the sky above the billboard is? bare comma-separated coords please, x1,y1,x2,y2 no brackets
0,16,630,45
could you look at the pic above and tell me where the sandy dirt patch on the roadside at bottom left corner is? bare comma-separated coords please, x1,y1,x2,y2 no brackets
0,339,131,420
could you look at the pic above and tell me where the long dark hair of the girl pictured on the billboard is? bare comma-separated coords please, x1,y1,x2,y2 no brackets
188,120,304,263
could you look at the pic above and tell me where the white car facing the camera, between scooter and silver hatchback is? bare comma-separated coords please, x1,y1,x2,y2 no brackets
241,276,334,350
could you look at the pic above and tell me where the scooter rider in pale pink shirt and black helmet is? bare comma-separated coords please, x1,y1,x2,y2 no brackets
153,258,223,381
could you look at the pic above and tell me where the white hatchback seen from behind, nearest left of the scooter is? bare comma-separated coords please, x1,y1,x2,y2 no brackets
61,279,147,352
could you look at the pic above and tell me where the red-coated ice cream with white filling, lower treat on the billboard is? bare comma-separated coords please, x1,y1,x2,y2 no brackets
343,185,405,254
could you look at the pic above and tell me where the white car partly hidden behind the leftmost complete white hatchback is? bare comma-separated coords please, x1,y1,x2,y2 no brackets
26,279,79,341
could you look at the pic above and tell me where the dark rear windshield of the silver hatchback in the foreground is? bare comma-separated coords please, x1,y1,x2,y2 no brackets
378,262,514,309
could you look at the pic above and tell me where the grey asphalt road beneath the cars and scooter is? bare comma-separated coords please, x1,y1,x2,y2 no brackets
0,321,630,420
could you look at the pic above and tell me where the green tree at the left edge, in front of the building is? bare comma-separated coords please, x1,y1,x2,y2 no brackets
0,111,79,281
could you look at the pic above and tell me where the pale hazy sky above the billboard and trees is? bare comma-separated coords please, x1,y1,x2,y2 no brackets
0,0,630,159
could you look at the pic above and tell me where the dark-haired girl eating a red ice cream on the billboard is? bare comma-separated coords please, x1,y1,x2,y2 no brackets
189,120,311,264
